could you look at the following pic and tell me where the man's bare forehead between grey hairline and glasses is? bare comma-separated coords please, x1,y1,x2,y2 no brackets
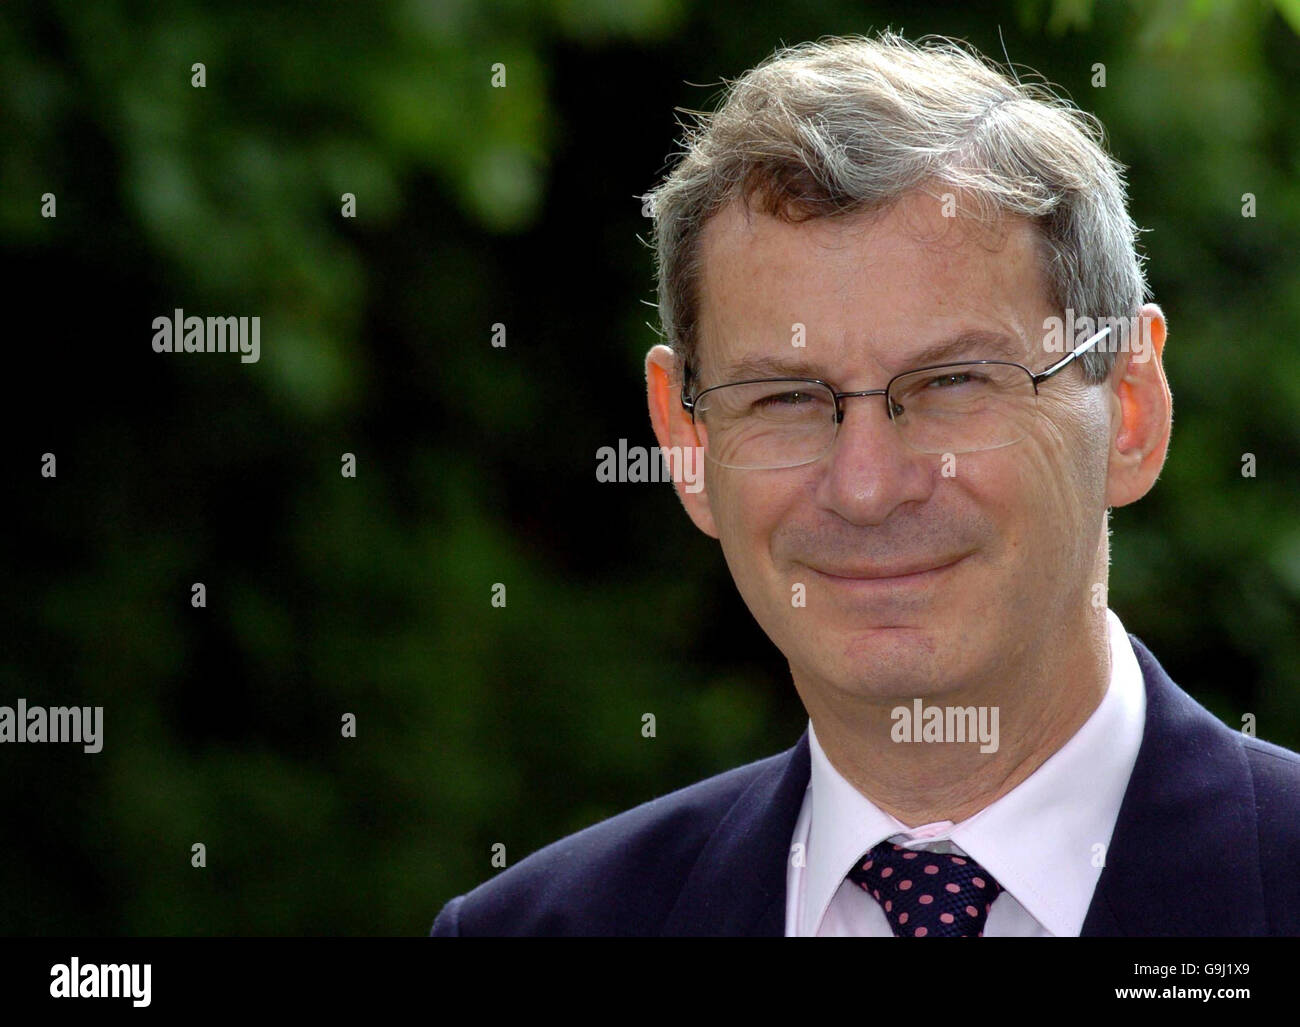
697,192,1054,377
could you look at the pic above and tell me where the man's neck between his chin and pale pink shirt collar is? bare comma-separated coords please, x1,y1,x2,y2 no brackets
796,608,1110,827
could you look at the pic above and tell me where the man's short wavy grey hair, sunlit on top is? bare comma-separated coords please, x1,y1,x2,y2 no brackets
642,31,1149,384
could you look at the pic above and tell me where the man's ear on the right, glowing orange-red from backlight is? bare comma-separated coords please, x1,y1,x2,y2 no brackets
1106,303,1174,507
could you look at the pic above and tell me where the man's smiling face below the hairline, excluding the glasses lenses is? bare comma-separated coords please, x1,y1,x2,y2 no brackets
693,192,1110,702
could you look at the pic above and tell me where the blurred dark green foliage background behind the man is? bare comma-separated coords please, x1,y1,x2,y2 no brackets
0,0,1300,935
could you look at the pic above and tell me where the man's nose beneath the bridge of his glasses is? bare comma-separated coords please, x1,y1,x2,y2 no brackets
818,393,935,525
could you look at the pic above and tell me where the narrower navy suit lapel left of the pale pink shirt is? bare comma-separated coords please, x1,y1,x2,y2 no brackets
663,729,810,937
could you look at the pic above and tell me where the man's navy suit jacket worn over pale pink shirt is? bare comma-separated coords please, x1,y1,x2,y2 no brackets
430,634,1300,937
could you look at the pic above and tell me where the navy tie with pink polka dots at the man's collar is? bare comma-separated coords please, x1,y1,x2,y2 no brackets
849,841,1002,937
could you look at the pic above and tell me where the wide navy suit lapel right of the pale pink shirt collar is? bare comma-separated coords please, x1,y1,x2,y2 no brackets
1080,644,1266,937
